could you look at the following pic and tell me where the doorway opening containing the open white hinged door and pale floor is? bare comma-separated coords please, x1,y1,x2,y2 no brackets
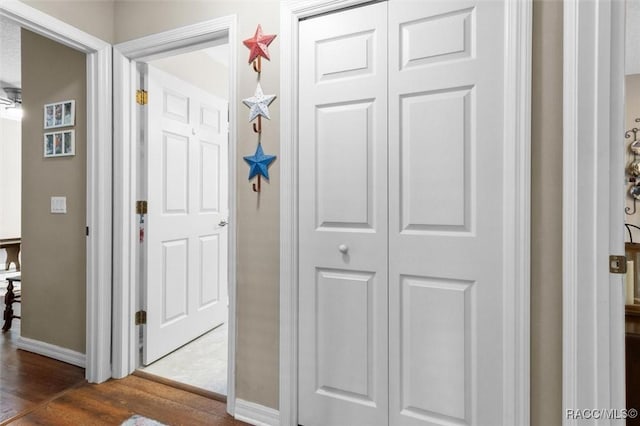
137,41,230,399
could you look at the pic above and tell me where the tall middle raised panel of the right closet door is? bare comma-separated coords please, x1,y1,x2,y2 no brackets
399,87,473,231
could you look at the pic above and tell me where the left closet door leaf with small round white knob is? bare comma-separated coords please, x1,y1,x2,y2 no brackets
299,3,388,426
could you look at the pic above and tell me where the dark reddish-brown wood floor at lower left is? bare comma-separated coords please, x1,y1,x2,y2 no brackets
0,321,246,426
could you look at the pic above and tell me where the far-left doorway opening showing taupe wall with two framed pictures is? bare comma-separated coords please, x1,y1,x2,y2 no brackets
0,18,89,367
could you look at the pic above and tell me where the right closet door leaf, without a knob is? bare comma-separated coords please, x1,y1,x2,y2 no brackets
389,0,513,426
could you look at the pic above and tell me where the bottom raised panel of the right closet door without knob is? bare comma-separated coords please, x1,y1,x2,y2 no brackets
400,276,475,419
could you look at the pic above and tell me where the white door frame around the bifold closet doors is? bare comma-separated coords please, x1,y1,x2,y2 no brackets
280,0,532,425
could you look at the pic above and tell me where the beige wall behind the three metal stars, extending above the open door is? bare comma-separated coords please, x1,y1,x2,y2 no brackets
114,0,280,408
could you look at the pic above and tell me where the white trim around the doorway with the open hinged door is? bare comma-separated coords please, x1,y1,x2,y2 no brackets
112,15,237,414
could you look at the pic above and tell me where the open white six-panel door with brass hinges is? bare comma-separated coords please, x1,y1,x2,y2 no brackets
143,66,229,365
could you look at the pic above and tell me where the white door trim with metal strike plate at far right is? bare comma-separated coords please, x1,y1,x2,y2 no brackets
562,0,625,425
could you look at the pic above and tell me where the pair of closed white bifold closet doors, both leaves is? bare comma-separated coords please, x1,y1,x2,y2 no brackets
298,0,508,426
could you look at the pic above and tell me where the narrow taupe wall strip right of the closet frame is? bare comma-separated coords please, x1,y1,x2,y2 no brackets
531,0,563,426
